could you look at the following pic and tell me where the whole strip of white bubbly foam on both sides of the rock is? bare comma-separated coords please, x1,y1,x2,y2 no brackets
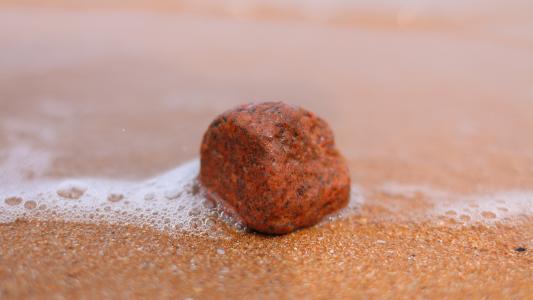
0,160,533,234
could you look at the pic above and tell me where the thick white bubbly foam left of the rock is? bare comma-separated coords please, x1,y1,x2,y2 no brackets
0,160,240,235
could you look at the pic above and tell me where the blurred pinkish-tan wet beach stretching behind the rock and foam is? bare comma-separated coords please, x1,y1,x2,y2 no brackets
0,0,533,190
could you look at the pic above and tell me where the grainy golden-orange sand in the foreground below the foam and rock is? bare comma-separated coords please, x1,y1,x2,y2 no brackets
0,218,533,299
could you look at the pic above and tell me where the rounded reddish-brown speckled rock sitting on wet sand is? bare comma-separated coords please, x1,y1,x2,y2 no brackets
200,102,350,234
